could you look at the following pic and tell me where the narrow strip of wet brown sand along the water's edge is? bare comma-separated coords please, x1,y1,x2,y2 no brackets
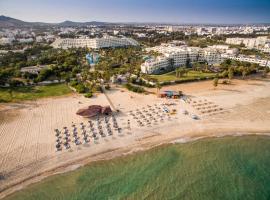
0,131,270,199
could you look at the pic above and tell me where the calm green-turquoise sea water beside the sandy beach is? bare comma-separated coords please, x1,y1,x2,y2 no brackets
6,136,270,200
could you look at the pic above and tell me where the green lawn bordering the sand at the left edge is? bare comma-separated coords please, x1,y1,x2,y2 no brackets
0,84,71,102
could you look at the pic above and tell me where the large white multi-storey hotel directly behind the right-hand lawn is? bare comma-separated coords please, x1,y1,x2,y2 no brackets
141,45,223,74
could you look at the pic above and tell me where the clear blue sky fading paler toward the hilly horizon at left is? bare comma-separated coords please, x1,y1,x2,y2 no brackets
0,0,270,24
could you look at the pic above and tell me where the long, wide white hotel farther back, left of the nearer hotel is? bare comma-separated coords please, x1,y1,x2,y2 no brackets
51,36,139,49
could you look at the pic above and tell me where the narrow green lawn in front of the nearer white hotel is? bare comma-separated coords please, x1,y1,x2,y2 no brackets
148,70,215,82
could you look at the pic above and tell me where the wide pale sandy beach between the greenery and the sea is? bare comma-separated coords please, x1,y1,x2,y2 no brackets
0,78,270,198
